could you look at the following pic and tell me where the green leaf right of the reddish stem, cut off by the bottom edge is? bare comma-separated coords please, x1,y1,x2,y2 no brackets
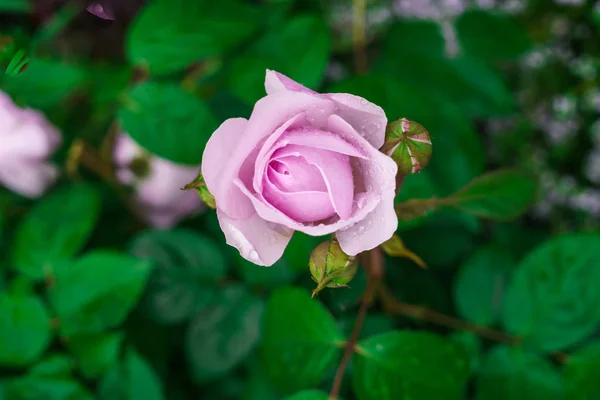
352,331,470,400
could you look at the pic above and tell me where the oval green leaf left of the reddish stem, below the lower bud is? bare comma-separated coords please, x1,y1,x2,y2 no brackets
262,287,344,392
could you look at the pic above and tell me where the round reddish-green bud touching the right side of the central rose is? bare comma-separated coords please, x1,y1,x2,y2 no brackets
381,118,432,176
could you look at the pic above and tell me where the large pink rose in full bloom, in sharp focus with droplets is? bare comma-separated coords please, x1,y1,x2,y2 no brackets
202,70,398,266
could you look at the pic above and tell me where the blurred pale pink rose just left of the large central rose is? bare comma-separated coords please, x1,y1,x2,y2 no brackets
113,134,204,228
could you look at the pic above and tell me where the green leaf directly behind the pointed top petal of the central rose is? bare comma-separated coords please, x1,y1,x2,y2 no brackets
229,14,331,104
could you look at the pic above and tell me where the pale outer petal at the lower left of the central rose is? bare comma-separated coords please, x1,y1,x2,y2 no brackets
217,207,294,267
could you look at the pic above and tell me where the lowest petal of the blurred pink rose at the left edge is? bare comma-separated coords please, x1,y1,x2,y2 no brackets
0,160,59,198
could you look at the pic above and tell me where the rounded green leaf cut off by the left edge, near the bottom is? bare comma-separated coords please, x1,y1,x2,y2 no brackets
0,293,52,367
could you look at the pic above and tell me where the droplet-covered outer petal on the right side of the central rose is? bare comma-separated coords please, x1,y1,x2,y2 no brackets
329,115,398,255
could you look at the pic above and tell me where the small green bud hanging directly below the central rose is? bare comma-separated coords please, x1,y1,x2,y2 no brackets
308,239,358,296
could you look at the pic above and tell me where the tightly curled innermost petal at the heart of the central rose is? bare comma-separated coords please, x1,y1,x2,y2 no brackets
267,157,327,193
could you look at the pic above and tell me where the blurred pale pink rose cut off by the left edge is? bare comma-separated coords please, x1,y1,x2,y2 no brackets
0,92,62,198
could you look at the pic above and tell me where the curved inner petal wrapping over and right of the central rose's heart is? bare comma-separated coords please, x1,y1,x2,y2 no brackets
273,145,354,219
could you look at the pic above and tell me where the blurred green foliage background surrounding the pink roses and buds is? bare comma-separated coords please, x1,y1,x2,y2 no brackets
0,0,600,400
